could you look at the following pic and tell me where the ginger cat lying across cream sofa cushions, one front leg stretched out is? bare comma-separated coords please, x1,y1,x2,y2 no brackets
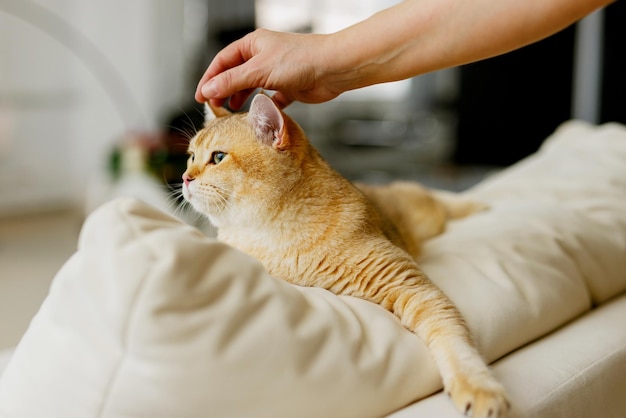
183,94,509,418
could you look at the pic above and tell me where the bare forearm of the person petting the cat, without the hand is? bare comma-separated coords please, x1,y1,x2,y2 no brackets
325,0,611,90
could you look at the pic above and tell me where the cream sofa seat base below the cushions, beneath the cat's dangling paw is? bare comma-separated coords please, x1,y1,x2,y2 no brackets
389,292,626,418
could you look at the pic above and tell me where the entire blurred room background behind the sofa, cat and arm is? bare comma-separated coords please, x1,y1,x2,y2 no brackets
0,0,626,348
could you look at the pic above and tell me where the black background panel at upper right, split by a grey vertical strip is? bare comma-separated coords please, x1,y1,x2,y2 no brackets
453,2,626,165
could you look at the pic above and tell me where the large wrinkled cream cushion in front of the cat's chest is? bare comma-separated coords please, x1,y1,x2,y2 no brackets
0,200,428,418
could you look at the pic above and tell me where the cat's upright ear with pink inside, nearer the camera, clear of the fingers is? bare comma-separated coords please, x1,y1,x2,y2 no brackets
248,94,287,150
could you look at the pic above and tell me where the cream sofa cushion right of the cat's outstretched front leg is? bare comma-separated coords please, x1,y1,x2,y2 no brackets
421,122,626,361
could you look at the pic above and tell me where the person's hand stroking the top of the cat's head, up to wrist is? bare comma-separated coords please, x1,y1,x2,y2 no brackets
195,29,345,109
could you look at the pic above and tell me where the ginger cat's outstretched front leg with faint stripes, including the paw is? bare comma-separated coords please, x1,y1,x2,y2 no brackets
348,248,509,418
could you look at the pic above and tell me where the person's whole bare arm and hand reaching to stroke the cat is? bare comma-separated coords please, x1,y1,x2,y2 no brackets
196,0,612,108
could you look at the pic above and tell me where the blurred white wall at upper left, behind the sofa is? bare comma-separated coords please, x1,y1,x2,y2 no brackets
0,0,188,214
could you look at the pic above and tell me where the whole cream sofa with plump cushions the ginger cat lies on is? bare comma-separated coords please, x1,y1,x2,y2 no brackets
0,121,626,418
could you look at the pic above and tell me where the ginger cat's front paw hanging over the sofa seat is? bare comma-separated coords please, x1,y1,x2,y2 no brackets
446,375,511,418
